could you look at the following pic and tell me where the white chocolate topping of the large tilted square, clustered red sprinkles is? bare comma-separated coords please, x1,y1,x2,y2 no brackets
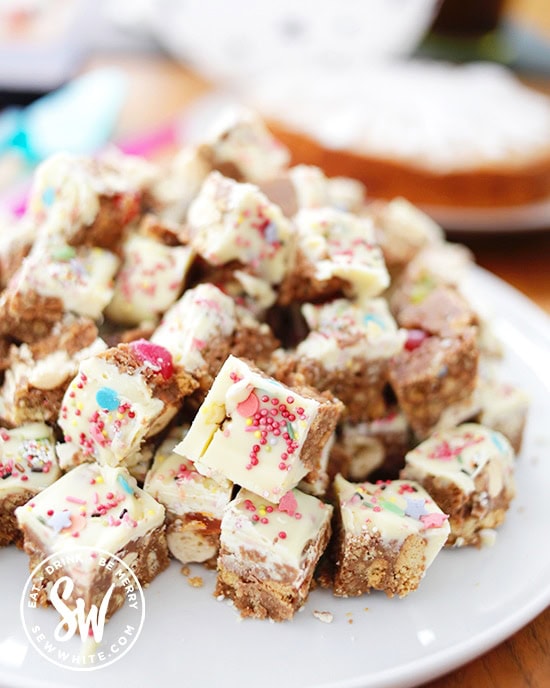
175,356,320,502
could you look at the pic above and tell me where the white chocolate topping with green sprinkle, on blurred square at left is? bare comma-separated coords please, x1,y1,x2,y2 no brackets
10,242,119,320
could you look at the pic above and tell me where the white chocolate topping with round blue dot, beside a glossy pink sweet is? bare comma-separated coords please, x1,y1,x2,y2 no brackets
58,356,165,466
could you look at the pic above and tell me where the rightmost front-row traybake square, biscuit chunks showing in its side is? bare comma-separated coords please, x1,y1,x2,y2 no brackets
333,475,450,597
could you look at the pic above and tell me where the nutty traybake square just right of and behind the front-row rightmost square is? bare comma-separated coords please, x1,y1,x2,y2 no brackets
401,423,515,547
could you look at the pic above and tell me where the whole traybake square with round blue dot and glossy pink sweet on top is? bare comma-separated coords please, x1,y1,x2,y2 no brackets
58,339,196,467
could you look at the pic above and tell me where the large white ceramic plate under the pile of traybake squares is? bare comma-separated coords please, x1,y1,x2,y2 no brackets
0,269,550,688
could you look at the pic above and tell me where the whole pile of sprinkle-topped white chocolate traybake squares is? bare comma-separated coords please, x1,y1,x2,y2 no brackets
0,111,527,621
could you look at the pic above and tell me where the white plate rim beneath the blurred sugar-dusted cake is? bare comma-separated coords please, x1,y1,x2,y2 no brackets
423,198,550,234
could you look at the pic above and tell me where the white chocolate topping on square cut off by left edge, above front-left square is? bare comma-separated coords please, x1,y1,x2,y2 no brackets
0,423,61,499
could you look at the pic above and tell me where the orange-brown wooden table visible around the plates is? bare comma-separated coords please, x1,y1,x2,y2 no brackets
88,56,550,688
